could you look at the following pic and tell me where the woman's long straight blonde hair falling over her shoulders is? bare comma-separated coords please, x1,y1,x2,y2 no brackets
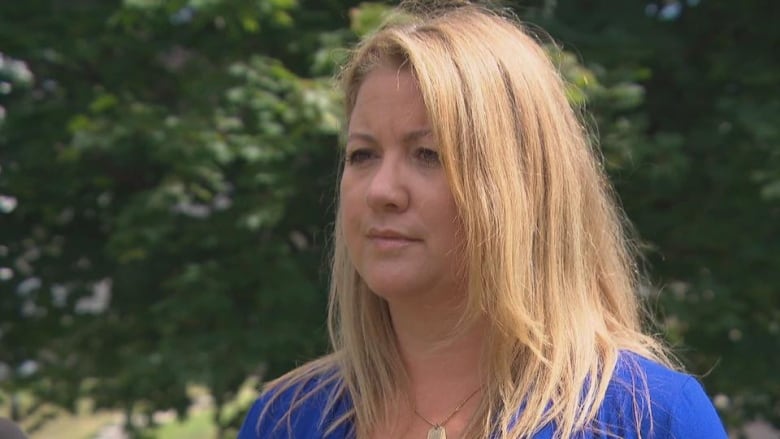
258,1,670,439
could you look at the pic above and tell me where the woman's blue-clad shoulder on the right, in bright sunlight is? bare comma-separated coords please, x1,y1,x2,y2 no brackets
596,353,727,439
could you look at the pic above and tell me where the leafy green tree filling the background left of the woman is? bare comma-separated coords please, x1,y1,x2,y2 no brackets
0,1,360,434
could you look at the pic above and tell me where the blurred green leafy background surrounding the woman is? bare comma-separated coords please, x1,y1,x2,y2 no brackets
0,0,780,439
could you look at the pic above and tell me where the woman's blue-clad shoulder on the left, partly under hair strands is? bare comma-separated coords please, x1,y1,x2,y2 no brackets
238,364,346,439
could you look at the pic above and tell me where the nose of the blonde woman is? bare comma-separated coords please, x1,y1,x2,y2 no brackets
366,154,409,211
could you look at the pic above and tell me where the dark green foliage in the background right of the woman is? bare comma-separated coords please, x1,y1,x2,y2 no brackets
532,0,780,425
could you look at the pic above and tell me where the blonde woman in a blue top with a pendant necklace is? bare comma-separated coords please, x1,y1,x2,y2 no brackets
239,2,726,439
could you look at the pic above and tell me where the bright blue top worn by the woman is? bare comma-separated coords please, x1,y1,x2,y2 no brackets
238,353,727,439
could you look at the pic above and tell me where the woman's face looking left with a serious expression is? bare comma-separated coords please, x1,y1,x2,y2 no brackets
340,67,463,301
